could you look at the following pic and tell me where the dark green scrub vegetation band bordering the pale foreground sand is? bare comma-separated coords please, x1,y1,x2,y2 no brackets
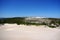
0,17,60,28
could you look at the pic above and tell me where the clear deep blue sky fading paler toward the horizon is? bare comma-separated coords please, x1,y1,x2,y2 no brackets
0,0,60,18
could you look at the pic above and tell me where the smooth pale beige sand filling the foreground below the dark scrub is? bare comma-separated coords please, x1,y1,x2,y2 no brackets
0,24,60,40
